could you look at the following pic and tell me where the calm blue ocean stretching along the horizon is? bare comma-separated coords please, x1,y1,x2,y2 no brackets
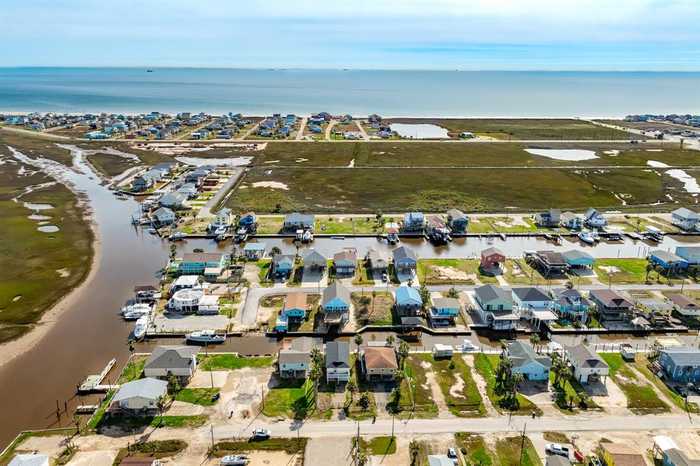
0,68,700,117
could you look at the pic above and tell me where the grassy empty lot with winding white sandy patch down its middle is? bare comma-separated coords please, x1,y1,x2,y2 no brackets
420,354,486,417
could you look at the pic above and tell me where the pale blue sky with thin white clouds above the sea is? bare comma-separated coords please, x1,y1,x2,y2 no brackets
0,0,700,71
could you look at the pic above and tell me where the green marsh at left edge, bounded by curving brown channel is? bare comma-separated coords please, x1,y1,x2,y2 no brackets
0,153,93,342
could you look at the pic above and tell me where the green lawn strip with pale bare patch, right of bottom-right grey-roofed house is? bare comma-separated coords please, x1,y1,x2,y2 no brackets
600,353,670,414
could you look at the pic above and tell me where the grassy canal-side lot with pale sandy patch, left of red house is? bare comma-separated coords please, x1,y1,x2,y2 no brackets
418,259,498,285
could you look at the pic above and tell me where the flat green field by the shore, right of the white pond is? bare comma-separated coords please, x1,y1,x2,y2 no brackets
386,118,639,140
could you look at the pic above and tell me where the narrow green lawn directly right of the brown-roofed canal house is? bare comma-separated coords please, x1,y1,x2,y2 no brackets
397,355,438,418
